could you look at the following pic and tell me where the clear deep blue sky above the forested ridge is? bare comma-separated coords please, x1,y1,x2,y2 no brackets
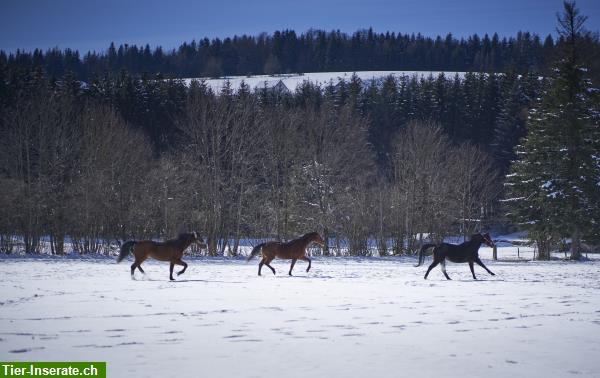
0,0,600,51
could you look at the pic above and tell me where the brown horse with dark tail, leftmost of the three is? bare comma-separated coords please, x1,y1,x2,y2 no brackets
117,232,206,281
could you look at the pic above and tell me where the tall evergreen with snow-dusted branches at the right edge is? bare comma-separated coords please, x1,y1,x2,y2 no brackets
507,2,600,259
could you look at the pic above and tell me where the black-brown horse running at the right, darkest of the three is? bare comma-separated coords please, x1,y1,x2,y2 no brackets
415,233,495,280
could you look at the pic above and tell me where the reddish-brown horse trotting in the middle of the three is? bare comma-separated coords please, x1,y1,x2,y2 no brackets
246,232,325,276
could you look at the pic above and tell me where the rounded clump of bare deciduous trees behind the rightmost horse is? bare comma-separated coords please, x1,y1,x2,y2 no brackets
390,122,499,253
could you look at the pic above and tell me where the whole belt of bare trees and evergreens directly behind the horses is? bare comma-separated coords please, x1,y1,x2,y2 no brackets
0,3,600,258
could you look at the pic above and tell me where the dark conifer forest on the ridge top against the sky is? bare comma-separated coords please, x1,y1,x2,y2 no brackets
5,29,600,81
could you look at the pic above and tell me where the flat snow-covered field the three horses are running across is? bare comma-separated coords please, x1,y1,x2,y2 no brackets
0,248,600,378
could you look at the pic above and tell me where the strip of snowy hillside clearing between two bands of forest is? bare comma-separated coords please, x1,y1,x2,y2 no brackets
183,71,465,92
